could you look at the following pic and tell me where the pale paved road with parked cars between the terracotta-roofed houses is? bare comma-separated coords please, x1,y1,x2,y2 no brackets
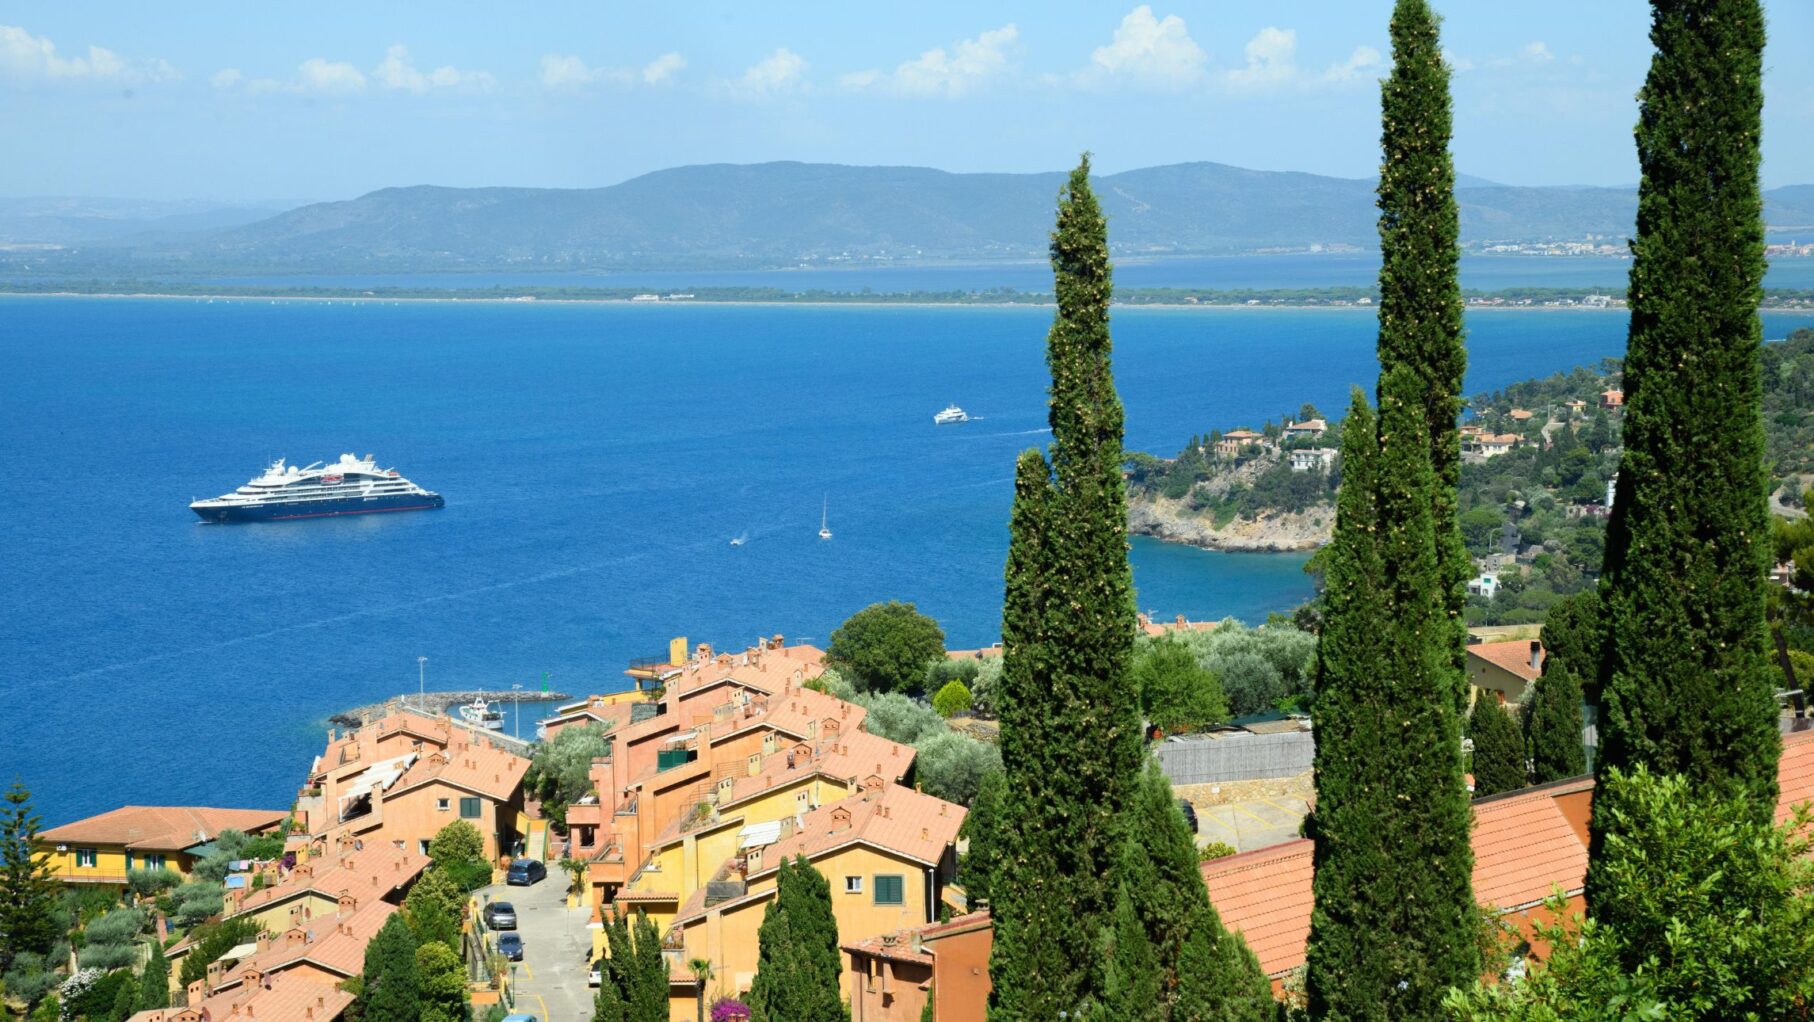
479,870,591,1022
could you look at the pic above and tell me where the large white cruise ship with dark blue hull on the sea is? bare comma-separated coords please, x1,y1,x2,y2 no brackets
189,454,446,523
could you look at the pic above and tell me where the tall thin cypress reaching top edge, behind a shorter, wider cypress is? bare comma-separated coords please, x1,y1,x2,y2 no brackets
1379,0,1473,712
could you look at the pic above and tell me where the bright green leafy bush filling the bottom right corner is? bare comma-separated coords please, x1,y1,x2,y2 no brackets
1449,764,1814,1022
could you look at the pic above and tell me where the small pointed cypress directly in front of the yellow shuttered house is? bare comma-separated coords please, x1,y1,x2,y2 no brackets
749,855,851,1022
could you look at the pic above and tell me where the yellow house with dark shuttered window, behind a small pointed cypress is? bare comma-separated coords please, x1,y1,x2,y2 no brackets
664,784,965,1011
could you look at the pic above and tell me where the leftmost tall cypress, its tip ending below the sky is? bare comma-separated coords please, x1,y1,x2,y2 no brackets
989,156,1141,1022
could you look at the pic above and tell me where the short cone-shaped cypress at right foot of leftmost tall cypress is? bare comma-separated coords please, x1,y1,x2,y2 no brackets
1103,764,1273,1022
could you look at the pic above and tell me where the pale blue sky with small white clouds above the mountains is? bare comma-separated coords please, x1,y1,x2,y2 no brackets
0,0,1814,203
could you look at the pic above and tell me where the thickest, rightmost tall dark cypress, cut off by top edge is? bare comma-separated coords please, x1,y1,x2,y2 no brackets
1587,0,1781,871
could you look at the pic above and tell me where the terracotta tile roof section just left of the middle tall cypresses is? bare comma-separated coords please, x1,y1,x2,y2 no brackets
1203,839,1313,977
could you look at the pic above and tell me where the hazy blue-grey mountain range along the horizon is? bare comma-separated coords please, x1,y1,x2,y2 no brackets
0,163,1814,274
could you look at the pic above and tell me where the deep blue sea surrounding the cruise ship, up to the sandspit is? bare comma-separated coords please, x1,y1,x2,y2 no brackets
10,298,1814,824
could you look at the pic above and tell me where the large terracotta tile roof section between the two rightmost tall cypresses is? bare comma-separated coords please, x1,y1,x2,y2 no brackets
1473,777,1593,911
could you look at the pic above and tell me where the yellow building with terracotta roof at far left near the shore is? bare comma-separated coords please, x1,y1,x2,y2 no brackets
36,806,288,886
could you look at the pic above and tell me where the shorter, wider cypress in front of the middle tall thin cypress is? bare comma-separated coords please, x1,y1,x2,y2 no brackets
1306,377,1480,1020
